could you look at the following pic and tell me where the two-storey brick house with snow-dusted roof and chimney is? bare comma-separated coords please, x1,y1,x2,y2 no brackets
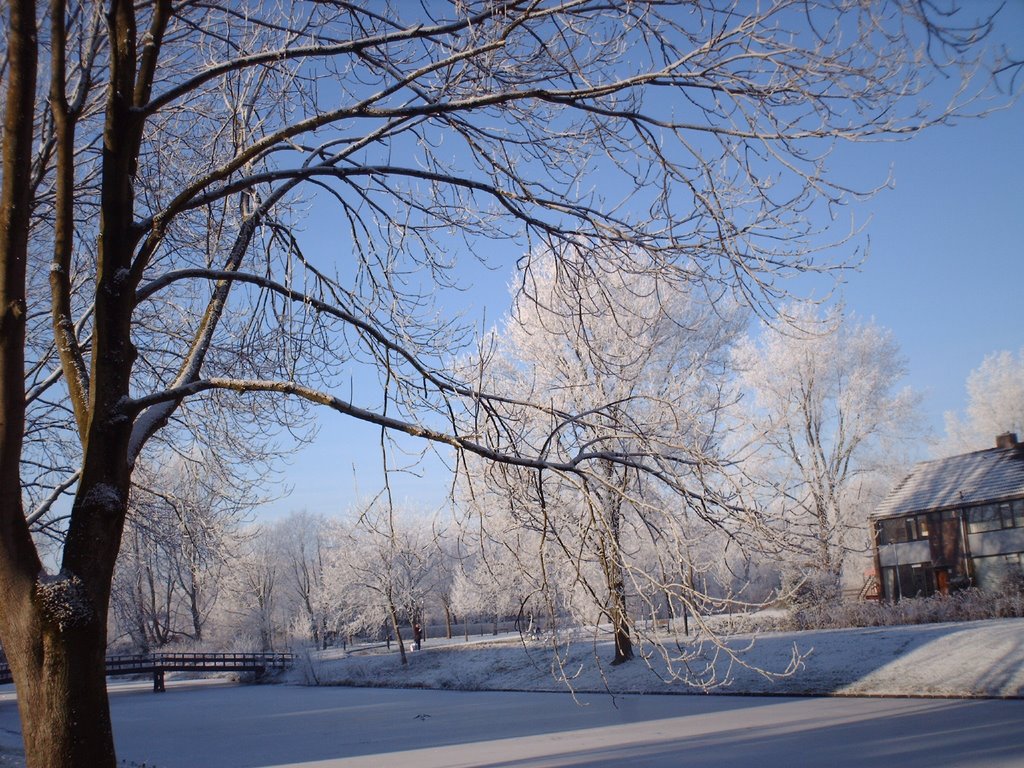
870,433,1024,600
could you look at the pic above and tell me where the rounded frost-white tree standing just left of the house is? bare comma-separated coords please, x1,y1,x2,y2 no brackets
734,304,922,595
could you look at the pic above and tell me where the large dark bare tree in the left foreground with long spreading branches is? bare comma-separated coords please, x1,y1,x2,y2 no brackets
0,0,1004,768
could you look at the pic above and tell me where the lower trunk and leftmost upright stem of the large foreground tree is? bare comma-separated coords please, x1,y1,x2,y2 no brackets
0,0,127,768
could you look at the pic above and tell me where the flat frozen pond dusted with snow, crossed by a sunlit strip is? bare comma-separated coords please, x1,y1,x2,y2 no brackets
0,684,1024,768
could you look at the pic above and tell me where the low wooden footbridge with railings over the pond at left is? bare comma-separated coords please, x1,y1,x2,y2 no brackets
0,653,295,693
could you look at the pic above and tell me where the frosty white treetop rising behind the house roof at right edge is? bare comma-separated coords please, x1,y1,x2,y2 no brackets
938,347,1024,456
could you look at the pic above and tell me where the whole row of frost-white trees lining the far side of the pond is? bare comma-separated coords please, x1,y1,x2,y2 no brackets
103,269,1024,660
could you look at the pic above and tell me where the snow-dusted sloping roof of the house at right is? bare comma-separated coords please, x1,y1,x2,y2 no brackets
871,442,1024,517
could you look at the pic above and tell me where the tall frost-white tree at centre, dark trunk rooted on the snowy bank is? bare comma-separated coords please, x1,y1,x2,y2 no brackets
468,245,743,664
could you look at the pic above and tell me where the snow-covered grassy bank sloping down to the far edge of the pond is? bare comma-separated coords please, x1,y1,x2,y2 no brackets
301,618,1024,697
